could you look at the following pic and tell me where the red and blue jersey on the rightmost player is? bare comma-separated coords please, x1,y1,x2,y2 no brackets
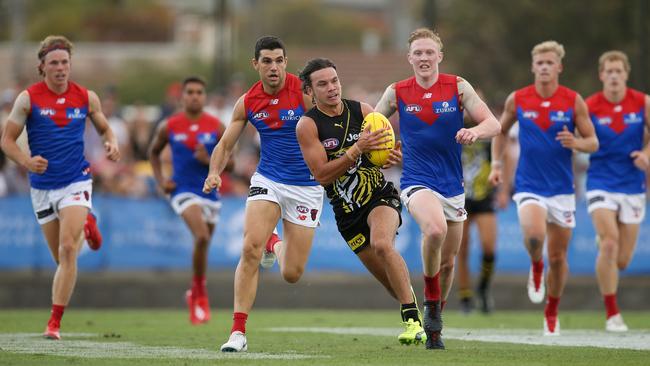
586,88,646,194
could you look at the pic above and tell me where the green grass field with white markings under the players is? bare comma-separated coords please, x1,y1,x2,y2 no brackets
0,308,650,366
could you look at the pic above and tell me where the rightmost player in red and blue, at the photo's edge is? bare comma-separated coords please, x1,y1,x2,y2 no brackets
586,51,650,332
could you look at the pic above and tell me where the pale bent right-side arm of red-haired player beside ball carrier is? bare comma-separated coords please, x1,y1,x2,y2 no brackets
456,77,501,144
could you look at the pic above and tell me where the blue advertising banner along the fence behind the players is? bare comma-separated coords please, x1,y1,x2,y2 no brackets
0,196,650,274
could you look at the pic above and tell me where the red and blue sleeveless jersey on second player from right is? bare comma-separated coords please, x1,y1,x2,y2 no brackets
515,85,577,197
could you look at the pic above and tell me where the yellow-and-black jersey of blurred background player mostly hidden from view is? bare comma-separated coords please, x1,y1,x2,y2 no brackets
462,140,494,201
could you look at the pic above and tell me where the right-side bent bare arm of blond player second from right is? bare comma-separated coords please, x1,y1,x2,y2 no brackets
555,95,598,153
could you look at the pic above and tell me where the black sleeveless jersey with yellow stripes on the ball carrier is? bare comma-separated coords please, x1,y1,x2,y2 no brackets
305,99,386,226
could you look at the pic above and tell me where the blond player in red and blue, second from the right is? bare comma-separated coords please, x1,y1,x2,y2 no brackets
489,41,598,335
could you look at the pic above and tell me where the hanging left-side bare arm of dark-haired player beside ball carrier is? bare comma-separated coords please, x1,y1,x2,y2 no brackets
203,94,247,193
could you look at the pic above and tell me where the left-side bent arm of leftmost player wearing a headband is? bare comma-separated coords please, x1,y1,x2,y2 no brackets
1,90,47,174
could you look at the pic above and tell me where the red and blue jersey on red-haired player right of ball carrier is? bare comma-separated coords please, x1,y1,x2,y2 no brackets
395,74,464,197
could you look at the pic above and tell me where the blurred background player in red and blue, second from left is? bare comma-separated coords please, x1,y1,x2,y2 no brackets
149,77,224,324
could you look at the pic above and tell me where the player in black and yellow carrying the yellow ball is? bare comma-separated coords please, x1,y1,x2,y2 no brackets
297,58,426,344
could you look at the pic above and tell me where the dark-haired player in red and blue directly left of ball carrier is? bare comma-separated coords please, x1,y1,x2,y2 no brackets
204,36,323,352
